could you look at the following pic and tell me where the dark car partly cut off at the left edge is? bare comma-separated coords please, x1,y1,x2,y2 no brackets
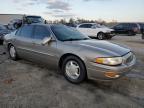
0,25,10,44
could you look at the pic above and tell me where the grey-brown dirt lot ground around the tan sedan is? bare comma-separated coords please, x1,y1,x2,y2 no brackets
0,35,144,108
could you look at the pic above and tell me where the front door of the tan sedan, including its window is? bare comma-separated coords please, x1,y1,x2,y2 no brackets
32,25,58,66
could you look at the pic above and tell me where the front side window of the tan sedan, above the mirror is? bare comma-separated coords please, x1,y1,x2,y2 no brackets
34,26,51,40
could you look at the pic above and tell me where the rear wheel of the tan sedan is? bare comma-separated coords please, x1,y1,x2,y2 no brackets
8,45,18,61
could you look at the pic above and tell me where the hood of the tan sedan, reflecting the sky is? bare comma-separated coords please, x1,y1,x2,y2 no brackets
73,39,130,56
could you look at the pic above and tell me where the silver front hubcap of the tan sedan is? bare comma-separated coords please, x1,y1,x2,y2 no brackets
65,60,80,79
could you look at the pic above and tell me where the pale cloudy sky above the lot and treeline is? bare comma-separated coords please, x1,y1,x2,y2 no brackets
0,0,144,22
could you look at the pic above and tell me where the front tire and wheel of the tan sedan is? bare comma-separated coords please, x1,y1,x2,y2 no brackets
62,56,87,84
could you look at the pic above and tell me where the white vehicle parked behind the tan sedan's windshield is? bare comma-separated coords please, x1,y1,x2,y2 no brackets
76,23,115,40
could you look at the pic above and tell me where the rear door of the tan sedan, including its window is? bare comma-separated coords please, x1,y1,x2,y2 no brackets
14,25,34,60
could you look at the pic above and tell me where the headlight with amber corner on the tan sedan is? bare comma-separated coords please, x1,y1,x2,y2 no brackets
95,57,123,66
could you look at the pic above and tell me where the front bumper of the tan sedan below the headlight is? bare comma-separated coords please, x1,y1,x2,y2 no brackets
87,52,136,80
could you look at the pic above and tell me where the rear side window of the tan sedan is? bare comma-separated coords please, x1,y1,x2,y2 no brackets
20,25,33,38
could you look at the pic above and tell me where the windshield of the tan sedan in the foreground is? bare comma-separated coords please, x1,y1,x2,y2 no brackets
51,25,90,41
